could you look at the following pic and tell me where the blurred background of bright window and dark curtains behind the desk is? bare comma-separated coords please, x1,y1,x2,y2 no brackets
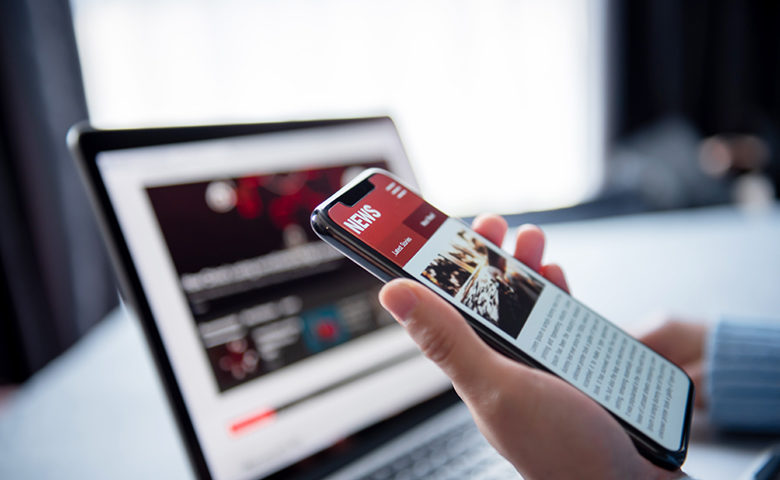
0,0,780,390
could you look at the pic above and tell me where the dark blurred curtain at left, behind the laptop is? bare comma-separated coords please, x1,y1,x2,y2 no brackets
0,0,116,382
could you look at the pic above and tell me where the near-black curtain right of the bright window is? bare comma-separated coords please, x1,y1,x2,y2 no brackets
608,0,780,191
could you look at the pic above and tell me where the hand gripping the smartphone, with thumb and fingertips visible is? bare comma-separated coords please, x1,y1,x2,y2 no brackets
379,216,681,479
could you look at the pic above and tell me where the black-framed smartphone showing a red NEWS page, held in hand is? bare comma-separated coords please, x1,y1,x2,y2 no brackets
311,169,694,470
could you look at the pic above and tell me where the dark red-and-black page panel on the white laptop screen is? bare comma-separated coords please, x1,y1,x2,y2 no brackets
146,161,393,392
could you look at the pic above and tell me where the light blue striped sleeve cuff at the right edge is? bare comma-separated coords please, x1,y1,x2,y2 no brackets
705,319,780,432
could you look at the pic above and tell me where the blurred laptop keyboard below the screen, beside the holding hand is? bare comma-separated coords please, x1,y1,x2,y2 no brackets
365,422,520,480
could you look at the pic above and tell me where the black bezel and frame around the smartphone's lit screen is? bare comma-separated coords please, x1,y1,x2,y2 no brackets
311,168,694,470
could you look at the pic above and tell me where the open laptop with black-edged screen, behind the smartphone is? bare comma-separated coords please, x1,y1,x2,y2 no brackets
69,117,517,480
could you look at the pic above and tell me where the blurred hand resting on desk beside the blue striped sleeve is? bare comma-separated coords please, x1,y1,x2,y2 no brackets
639,319,709,408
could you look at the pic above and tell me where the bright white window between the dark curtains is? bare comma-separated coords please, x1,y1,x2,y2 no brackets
73,0,604,215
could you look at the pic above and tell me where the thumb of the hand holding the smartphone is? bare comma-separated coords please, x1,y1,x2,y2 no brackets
379,279,502,396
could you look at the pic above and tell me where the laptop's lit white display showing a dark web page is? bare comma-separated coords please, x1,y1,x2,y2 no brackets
96,121,448,479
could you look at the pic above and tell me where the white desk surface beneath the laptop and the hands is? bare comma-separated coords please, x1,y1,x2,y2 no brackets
0,206,780,479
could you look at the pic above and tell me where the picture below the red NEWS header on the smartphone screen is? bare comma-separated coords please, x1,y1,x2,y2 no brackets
422,229,544,337
